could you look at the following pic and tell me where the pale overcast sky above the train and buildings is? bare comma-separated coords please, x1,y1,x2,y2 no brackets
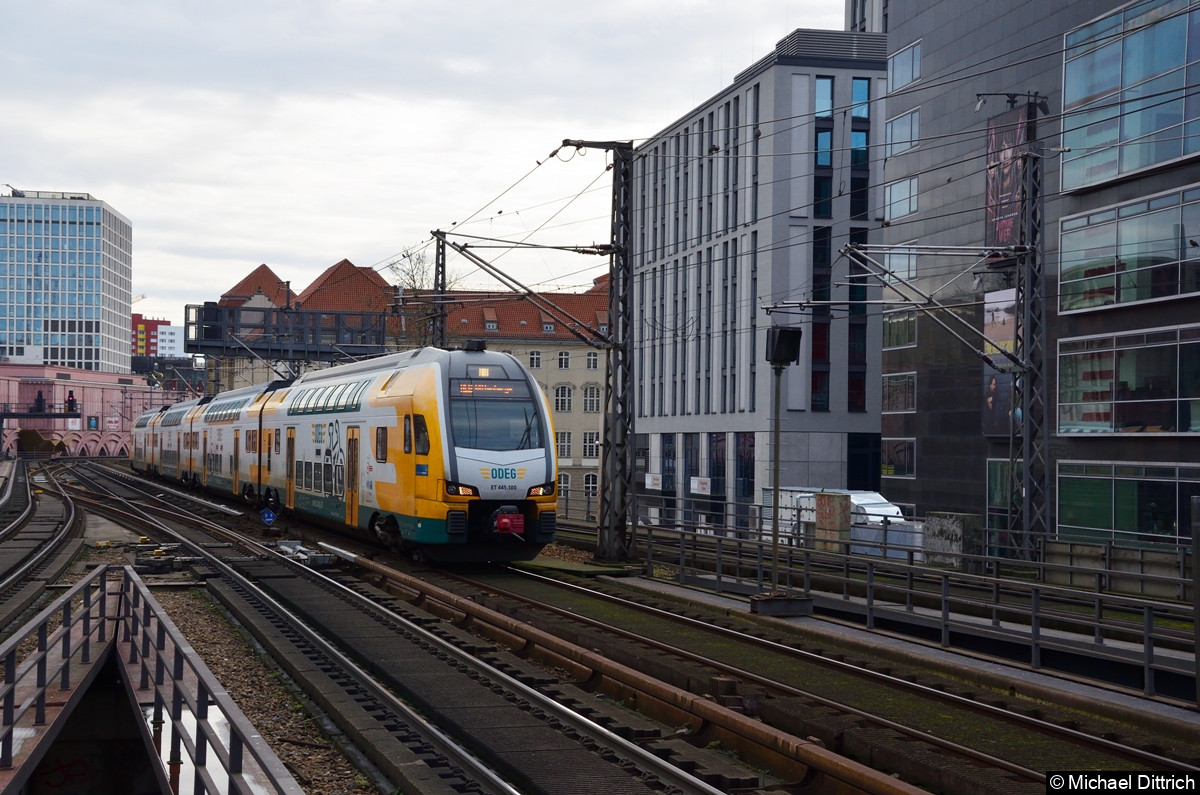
0,0,845,324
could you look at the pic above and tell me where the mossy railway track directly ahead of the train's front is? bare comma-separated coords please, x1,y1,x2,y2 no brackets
372,559,1200,793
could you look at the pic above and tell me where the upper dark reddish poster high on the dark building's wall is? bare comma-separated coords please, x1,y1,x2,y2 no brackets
984,104,1030,247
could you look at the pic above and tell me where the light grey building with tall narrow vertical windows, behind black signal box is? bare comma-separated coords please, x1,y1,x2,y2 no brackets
631,30,887,526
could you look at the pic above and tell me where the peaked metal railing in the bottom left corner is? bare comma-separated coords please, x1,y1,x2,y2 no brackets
0,566,302,794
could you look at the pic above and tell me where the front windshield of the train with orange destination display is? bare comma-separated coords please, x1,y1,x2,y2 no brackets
450,378,545,450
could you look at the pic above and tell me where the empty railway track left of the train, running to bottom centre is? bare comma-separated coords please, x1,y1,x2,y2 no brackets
49,463,806,793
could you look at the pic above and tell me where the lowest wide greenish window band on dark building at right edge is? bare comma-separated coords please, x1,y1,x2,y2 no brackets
1057,461,1200,544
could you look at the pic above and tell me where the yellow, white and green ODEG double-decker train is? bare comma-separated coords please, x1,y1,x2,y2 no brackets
130,343,557,562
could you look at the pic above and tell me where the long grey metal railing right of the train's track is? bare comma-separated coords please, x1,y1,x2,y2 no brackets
637,527,1195,695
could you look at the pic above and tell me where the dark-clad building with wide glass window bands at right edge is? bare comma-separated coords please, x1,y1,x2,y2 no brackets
882,0,1200,543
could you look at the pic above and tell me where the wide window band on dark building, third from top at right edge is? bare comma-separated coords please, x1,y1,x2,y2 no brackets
1058,325,1200,434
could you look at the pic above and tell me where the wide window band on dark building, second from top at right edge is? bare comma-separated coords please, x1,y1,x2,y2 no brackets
1058,187,1200,312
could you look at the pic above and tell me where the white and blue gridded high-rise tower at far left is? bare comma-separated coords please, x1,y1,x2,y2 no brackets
0,190,133,372
